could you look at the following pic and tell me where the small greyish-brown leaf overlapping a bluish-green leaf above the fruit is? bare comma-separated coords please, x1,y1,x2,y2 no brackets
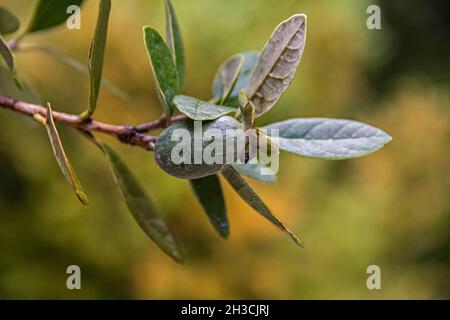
213,54,245,105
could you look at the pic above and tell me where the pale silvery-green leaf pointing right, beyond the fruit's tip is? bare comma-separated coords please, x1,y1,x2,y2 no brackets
264,118,392,160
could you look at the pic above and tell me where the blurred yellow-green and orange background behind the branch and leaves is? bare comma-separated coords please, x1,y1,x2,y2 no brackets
0,0,450,299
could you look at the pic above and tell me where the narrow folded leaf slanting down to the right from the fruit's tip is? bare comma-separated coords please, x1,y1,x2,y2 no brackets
222,166,303,248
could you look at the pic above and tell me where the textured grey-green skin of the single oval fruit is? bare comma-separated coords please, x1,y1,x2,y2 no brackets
154,116,243,179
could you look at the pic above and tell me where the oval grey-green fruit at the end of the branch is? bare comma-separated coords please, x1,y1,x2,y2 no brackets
155,116,246,179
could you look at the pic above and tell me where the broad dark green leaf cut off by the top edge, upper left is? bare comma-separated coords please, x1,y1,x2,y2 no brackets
27,0,83,33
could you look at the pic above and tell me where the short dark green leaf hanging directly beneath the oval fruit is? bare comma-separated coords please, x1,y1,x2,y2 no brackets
190,175,230,239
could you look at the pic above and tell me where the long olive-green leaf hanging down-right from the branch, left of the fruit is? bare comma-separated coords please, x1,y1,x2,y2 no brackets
102,144,183,262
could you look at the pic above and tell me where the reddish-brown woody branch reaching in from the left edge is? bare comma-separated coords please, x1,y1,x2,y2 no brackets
0,93,186,150
